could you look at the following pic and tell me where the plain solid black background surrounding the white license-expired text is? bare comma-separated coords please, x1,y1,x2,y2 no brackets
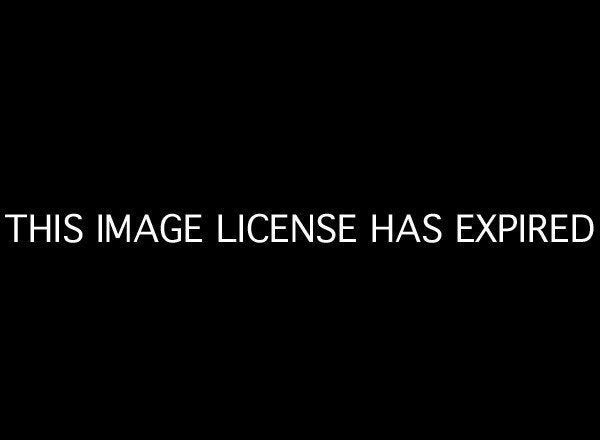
1,5,598,433
